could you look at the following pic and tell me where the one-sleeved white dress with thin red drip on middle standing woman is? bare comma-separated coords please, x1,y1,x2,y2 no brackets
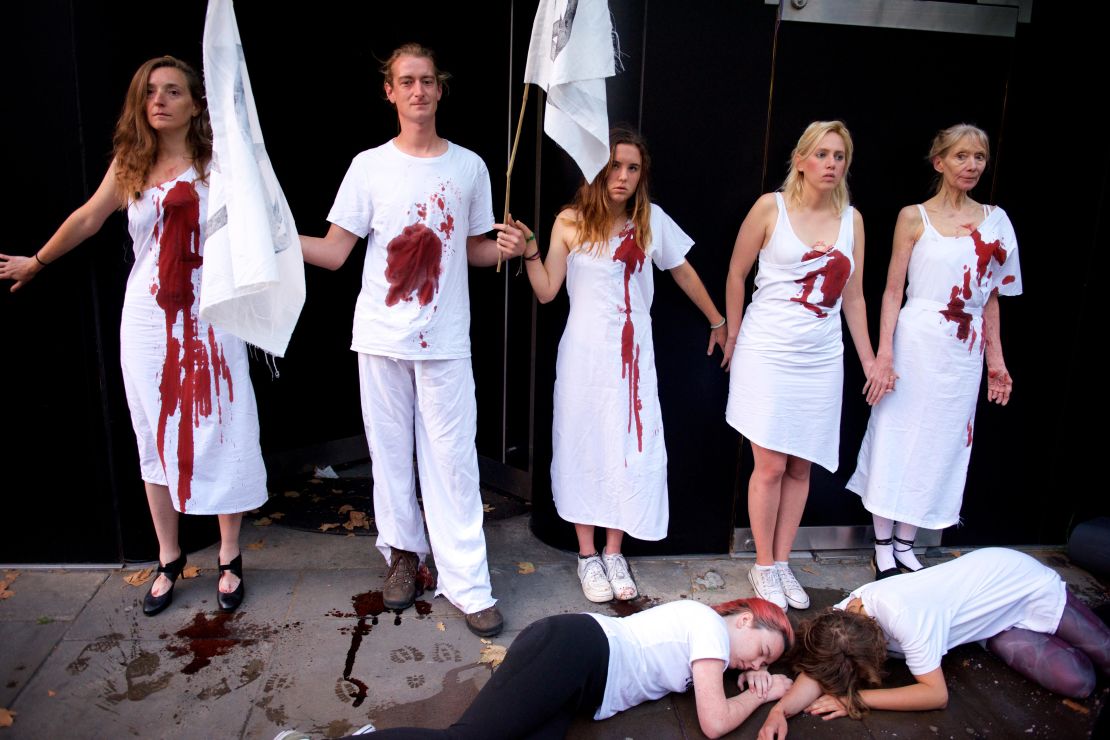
552,204,694,540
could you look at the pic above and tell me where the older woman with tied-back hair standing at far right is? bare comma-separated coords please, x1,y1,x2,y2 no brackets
848,124,1021,578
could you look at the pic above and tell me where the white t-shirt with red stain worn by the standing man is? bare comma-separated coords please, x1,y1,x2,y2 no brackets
327,141,494,359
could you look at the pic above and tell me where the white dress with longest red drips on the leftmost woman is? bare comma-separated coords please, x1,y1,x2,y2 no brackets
120,169,266,514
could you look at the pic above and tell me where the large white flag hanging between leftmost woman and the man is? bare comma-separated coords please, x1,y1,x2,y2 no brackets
201,0,304,357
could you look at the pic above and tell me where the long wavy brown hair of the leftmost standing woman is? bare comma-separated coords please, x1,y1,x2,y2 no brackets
112,57,212,203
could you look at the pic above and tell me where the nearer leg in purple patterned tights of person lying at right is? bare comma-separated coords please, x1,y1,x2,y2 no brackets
987,628,1094,699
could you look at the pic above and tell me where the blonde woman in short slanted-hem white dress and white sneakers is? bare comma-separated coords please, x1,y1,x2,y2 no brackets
725,121,881,609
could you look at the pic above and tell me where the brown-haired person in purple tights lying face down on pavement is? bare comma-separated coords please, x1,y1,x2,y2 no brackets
759,548,1110,740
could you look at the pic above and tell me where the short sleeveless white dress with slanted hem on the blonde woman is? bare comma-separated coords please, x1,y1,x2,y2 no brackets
725,193,856,472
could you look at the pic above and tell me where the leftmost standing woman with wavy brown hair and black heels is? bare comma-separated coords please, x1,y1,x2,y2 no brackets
0,57,266,616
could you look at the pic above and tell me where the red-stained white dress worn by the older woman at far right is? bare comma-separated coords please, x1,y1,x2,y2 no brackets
848,205,1021,529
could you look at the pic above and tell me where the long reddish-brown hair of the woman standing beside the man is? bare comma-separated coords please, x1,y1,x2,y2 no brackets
568,129,652,253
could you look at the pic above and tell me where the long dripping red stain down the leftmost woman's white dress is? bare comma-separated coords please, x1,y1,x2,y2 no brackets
154,181,231,511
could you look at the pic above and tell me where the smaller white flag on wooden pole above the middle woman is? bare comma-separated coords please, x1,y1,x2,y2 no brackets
524,0,616,182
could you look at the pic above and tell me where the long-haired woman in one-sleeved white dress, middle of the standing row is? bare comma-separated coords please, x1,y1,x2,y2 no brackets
517,130,725,602
